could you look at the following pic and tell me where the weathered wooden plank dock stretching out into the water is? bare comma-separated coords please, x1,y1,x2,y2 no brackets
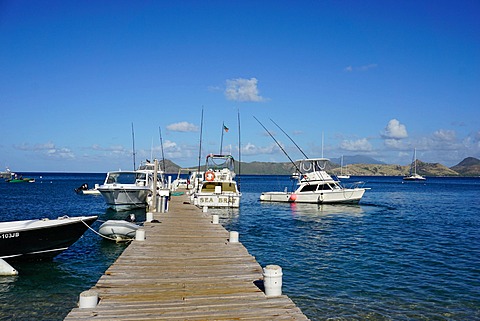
65,191,308,321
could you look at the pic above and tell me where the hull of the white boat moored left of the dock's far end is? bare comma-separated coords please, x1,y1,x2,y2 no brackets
98,186,150,211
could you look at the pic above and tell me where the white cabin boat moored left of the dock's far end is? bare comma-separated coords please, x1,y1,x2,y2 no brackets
97,163,165,211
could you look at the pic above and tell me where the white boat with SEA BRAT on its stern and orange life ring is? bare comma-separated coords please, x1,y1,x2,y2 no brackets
190,154,242,208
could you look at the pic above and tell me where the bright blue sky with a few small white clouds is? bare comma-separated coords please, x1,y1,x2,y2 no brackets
0,0,480,172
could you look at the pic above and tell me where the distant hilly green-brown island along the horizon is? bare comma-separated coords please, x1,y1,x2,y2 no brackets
165,157,480,177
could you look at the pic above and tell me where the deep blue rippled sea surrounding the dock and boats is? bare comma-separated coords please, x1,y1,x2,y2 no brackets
0,173,480,320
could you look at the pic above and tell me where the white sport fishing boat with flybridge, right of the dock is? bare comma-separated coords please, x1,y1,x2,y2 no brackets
260,158,369,204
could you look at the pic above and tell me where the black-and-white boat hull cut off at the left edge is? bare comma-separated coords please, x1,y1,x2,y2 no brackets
0,216,97,260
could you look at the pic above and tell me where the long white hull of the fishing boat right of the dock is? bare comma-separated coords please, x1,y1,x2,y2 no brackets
260,188,365,204
